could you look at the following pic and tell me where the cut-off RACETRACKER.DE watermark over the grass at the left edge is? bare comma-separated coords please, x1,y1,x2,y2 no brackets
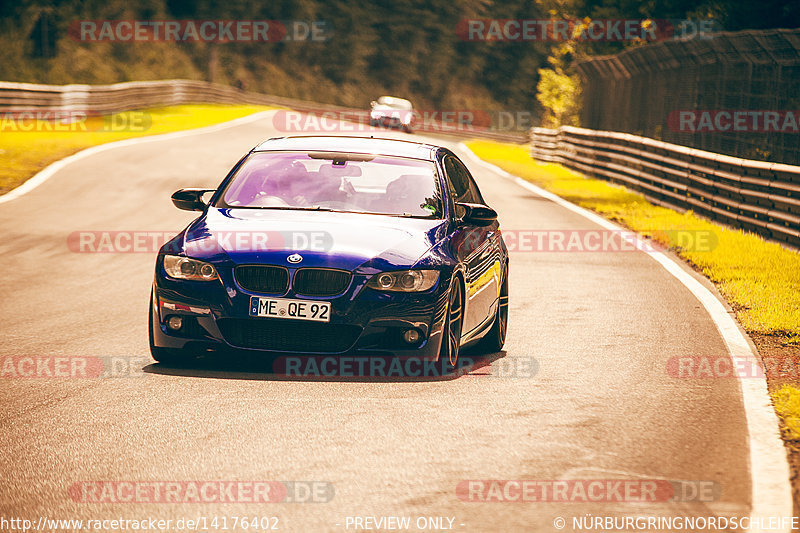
0,109,153,133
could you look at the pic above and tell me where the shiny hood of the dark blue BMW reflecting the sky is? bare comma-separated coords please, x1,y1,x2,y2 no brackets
183,207,446,270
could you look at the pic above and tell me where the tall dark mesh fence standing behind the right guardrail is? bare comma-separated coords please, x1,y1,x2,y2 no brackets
575,29,800,165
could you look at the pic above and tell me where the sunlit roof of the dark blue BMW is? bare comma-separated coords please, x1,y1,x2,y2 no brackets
253,135,440,161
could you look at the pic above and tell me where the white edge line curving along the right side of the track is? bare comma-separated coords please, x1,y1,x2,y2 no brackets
458,143,793,533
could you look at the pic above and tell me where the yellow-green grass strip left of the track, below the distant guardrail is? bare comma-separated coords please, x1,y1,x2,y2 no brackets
0,104,269,194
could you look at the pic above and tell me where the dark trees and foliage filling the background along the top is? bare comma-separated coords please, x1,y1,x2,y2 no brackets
0,0,800,123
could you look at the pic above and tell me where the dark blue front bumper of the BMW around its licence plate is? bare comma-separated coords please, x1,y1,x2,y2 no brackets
151,261,450,360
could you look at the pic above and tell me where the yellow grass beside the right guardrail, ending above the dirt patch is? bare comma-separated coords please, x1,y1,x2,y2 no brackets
467,141,800,334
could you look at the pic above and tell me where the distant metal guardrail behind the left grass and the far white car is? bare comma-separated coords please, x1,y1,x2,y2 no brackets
0,80,525,143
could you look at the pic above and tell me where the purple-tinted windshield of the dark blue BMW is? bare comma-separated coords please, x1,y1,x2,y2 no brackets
216,152,443,218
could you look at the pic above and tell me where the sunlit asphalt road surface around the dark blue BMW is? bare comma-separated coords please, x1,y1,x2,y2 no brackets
0,113,750,532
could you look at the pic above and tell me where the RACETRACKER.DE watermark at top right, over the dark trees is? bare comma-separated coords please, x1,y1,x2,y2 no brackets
456,18,718,42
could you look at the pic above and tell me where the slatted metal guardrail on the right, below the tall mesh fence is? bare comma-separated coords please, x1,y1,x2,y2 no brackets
530,126,800,248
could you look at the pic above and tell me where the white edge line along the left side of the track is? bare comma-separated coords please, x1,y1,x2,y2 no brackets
0,109,282,204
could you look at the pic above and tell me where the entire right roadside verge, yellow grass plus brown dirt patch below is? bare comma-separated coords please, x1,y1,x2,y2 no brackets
467,141,800,502
